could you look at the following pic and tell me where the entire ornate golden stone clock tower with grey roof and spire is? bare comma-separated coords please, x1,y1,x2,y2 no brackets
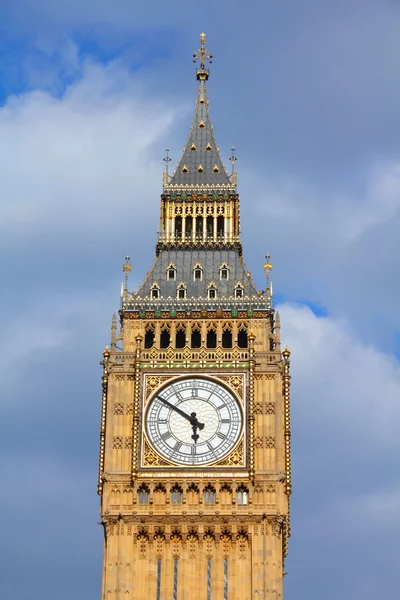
98,34,291,600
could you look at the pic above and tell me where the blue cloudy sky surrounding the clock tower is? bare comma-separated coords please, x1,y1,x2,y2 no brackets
0,0,400,600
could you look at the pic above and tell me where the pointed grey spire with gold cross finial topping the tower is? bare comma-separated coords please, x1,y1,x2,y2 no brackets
166,33,236,188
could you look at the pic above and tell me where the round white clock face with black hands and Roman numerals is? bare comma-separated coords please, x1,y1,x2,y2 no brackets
146,378,242,465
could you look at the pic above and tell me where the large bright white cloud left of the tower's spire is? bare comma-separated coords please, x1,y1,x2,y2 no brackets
0,56,184,244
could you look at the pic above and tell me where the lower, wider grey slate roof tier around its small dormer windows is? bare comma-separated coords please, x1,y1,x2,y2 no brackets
137,250,258,299
